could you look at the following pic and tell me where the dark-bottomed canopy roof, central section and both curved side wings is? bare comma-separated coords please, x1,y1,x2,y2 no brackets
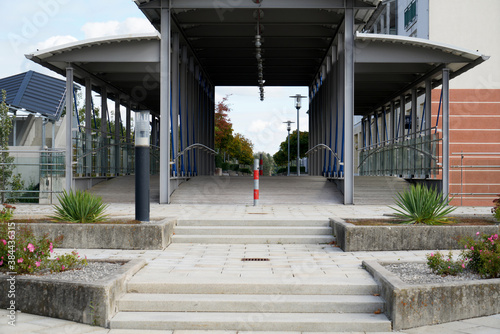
28,0,487,115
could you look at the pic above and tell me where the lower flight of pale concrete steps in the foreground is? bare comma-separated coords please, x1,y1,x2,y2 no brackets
110,277,391,332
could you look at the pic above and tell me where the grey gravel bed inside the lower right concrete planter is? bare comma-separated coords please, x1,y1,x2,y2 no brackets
384,262,481,284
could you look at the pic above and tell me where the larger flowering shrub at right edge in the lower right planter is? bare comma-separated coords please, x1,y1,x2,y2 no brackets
460,232,500,278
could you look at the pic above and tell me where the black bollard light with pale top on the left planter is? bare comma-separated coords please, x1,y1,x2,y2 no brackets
135,110,150,222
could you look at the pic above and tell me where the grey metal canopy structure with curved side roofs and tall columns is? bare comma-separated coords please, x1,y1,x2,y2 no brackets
27,0,487,204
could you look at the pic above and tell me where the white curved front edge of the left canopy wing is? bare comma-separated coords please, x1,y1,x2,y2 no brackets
25,32,161,59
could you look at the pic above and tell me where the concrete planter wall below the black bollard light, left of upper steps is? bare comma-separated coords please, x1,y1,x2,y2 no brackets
12,220,175,249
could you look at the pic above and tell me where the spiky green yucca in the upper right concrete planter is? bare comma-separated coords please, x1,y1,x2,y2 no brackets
390,184,456,225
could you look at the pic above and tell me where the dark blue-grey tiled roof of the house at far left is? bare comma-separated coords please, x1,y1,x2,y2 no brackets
0,71,66,120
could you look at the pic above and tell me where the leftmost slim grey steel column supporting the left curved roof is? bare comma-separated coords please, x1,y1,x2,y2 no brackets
65,63,73,192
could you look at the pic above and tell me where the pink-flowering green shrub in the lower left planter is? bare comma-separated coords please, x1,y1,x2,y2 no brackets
0,224,87,274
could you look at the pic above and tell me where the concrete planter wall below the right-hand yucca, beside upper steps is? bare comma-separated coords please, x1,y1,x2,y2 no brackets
331,219,500,252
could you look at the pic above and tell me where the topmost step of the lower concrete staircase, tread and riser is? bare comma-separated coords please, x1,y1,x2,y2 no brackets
127,273,379,298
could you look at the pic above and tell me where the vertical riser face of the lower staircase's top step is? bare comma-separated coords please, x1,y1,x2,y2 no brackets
128,282,379,295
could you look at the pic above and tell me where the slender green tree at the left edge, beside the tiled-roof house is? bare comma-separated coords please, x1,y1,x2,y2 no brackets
0,90,24,203
